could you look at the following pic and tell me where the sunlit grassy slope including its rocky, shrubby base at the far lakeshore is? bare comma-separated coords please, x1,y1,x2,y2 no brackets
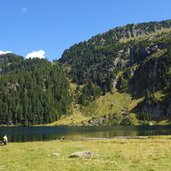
48,92,142,126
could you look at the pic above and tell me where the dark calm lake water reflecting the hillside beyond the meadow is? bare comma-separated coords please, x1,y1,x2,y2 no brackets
0,126,171,142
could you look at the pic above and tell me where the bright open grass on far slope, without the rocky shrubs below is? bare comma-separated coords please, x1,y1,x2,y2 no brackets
47,92,131,126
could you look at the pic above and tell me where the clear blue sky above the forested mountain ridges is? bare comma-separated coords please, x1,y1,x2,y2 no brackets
0,0,171,60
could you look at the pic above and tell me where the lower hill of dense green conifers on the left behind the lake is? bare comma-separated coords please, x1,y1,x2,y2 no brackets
0,54,71,126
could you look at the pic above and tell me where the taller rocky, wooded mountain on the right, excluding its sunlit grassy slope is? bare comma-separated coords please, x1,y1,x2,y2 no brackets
59,20,171,124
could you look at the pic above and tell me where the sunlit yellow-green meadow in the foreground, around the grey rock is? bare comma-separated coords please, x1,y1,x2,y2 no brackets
0,136,171,171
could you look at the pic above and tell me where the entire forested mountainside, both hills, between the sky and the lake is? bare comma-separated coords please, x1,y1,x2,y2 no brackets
0,20,171,125
